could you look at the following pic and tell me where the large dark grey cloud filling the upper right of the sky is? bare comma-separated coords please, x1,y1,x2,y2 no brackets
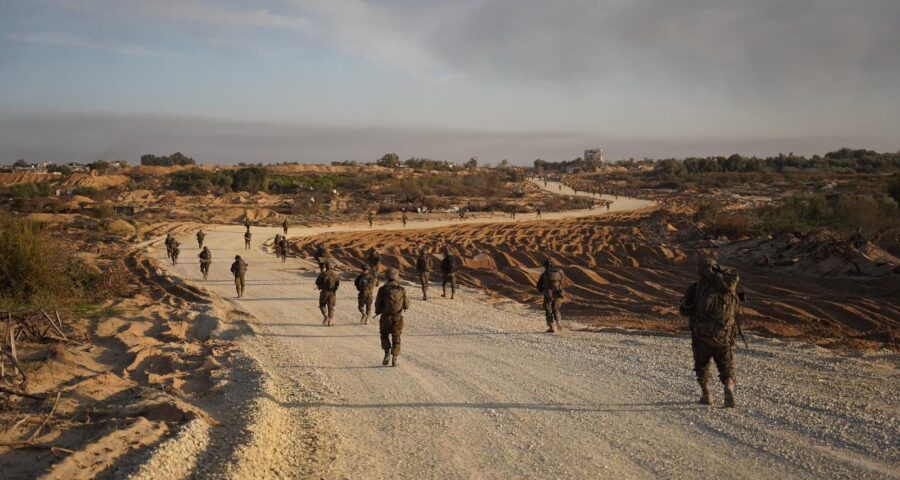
427,0,900,96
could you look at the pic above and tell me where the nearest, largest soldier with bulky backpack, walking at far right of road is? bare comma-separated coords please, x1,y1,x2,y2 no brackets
678,257,741,408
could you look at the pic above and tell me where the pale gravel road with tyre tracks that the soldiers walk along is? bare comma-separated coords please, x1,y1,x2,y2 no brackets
149,192,900,479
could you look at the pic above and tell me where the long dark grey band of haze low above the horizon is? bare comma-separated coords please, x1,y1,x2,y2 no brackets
0,114,884,164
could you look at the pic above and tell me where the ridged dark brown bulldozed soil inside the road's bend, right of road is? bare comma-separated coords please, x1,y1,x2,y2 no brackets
296,209,900,349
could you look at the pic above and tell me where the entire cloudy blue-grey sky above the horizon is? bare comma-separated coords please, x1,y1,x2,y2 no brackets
0,0,900,164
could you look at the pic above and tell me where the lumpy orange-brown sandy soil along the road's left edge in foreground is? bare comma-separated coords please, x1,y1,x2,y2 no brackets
0,234,243,478
